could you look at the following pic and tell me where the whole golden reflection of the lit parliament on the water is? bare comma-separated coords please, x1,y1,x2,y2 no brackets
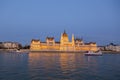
28,52,97,74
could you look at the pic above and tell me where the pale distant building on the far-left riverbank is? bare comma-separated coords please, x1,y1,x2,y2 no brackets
2,42,21,49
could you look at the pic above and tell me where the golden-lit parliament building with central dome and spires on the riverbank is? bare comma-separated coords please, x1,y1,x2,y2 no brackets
30,31,98,51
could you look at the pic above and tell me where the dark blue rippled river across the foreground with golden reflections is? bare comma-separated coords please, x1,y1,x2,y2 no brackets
0,52,120,80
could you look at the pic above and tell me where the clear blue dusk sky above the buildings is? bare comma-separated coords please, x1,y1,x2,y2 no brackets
0,0,120,45
